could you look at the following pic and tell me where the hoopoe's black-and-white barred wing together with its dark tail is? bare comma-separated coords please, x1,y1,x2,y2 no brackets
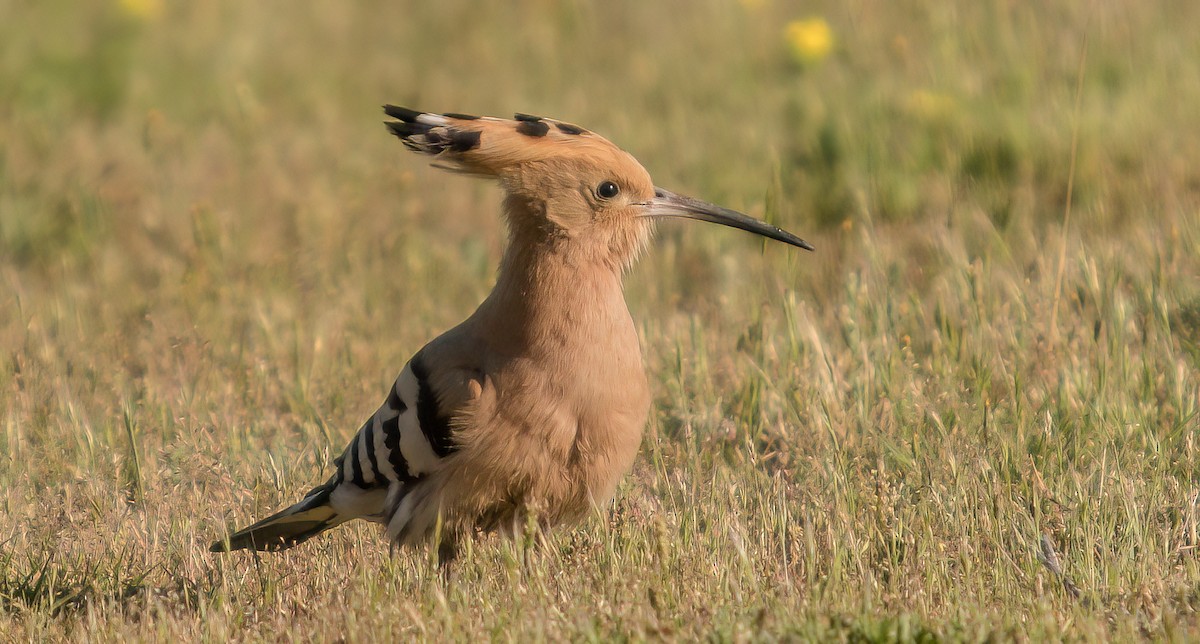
210,354,455,552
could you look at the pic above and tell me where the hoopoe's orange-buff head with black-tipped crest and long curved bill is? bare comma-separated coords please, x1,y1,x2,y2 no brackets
384,106,812,266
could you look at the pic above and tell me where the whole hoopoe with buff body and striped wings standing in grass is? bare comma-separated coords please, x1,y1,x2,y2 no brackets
211,106,812,561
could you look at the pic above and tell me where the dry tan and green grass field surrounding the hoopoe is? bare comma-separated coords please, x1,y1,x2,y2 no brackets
0,0,1200,640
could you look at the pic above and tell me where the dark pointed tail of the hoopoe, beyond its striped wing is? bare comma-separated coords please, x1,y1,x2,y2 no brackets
209,480,354,553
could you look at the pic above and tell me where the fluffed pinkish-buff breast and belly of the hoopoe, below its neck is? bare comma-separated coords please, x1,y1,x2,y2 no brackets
455,309,650,523
